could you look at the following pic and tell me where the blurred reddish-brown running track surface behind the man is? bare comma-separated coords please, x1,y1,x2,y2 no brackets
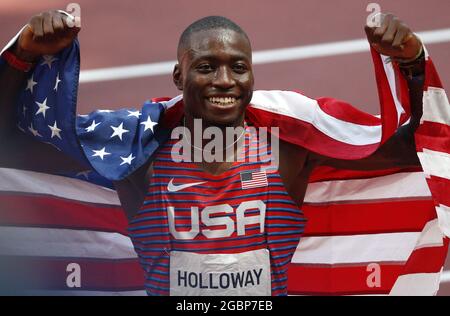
0,0,450,295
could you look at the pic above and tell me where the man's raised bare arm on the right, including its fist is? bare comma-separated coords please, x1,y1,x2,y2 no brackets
312,14,425,170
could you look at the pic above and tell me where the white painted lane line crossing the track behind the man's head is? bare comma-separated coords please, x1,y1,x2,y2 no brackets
80,28,450,83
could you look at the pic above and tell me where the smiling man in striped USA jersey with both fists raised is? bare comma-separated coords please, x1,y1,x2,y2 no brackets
0,12,436,295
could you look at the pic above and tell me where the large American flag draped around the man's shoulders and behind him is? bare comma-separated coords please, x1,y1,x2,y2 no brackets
0,35,450,295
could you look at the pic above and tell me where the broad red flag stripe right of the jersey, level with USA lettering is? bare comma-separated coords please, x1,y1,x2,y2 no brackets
303,200,436,236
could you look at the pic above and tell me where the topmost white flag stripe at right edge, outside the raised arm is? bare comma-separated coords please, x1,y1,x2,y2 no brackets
421,87,450,125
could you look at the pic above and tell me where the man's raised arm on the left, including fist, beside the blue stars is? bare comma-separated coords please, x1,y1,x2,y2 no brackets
0,11,81,172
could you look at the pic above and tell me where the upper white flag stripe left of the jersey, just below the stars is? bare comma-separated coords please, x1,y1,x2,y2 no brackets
0,168,120,205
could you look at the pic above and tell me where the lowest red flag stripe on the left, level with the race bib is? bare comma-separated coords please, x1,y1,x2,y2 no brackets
1,257,144,291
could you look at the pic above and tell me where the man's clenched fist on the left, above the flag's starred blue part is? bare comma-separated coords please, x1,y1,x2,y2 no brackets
14,11,80,62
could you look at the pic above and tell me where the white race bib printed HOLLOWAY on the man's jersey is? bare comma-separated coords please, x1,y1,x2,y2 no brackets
170,249,271,296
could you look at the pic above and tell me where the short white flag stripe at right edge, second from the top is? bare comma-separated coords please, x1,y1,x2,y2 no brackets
417,149,450,180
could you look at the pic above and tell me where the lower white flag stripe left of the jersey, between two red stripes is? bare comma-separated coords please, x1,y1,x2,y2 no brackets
0,226,137,259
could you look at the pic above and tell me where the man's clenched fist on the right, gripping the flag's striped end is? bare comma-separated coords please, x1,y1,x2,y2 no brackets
365,14,422,60
